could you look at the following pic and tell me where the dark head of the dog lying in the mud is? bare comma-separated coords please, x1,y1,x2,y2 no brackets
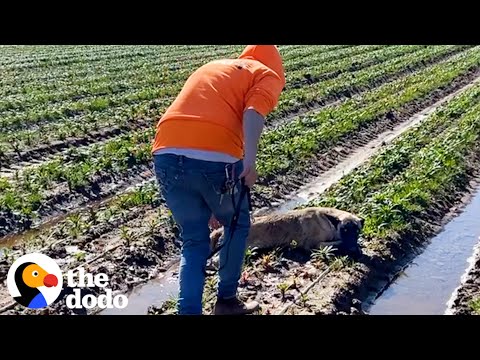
328,215,364,258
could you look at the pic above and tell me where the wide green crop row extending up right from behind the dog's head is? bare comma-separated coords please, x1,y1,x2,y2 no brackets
306,85,480,245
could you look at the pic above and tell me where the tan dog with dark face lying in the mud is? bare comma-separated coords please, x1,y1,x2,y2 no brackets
210,207,364,257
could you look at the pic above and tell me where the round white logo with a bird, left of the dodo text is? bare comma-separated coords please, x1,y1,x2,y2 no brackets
7,253,63,309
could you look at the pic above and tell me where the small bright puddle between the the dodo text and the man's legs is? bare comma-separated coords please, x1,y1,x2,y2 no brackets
98,267,179,315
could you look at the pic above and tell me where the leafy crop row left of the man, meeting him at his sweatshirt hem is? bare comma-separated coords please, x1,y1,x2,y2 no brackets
0,128,152,232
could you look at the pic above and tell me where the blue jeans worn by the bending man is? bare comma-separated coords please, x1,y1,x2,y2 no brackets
154,154,250,315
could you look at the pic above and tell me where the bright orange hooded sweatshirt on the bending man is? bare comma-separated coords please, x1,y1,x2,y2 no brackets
152,45,285,159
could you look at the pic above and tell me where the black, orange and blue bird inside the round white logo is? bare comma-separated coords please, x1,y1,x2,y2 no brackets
15,262,58,309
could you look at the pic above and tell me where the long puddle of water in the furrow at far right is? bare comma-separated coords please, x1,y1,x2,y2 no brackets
368,193,480,315
